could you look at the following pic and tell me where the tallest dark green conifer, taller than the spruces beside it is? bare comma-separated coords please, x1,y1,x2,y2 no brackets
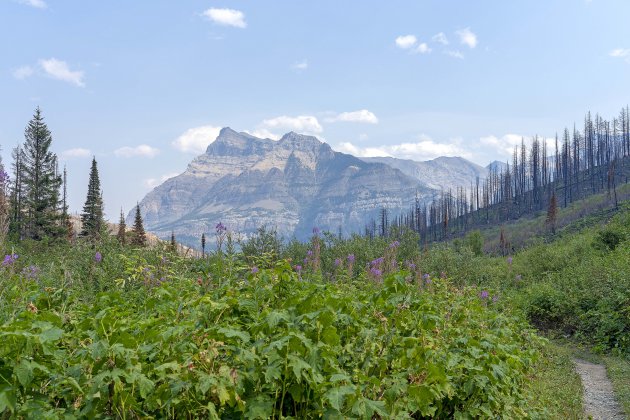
18,107,63,240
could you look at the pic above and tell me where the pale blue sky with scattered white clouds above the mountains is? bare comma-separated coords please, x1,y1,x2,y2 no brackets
0,0,630,220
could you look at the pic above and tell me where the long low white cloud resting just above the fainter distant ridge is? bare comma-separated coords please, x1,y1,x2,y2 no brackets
335,135,471,160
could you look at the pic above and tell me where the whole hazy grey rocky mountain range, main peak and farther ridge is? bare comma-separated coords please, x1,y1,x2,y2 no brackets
135,128,488,247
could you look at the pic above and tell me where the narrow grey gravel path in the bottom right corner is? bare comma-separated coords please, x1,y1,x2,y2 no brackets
574,359,626,420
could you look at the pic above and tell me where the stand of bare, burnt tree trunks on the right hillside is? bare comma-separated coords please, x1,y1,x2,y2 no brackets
365,106,630,243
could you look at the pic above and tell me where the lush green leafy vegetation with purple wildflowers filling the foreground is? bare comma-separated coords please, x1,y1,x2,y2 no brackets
0,199,630,418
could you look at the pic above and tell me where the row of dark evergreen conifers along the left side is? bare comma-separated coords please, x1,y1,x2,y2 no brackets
0,107,146,248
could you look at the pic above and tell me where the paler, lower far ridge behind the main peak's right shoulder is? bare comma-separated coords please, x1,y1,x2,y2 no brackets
361,157,488,191
